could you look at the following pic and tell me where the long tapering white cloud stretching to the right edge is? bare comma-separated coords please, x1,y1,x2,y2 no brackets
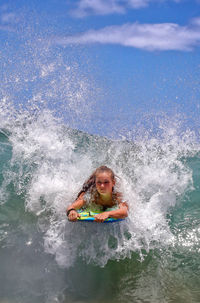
54,18,200,51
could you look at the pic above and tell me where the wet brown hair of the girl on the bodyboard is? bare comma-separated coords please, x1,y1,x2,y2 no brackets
77,165,115,198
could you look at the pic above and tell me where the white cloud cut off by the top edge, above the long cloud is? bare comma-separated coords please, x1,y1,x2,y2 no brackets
71,0,184,17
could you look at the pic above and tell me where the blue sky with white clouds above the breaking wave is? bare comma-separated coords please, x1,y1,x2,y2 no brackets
0,0,200,136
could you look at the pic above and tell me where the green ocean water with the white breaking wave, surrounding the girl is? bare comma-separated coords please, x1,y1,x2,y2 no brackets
0,107,200,303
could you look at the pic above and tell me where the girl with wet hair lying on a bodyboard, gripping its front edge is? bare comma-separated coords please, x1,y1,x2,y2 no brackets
67,166,128,222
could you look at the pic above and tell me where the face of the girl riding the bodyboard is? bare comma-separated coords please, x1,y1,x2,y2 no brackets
95,172,115,195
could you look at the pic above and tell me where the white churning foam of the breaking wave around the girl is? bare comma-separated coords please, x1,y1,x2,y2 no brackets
2,105,197,267
